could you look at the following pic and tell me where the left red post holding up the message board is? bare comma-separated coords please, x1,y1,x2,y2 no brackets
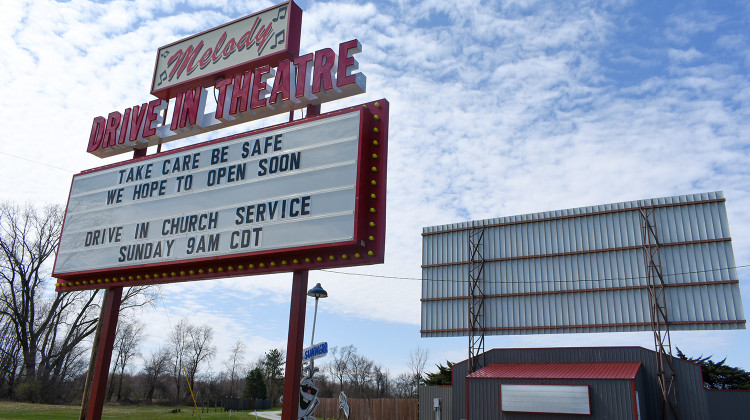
86,287,122,420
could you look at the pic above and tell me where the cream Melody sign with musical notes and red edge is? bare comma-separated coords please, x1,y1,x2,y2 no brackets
151,1,302,99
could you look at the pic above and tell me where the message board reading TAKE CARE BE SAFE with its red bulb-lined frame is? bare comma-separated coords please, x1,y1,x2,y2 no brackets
53,100,388,291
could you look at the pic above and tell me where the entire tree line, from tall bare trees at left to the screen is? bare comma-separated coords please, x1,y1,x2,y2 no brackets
0,202,428,404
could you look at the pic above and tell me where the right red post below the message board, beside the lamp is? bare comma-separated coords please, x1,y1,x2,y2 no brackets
281,270,308,420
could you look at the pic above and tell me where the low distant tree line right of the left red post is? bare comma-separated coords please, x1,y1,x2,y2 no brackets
107,334,429,406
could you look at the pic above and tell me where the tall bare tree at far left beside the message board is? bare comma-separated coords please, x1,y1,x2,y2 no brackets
0,202,152,401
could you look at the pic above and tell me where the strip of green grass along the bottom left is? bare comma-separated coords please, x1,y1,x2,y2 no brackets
0,401,280,420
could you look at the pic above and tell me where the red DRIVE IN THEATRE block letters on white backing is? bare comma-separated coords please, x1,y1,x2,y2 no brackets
87,39,367,158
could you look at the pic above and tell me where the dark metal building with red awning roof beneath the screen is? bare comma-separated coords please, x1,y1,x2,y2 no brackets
420,347,750,420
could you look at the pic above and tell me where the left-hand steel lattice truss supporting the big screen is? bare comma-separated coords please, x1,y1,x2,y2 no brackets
468,225,484,373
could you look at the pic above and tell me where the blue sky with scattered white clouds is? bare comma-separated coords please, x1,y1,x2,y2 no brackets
0,0,750,374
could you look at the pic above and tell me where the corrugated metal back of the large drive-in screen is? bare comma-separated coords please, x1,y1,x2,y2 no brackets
421,192,745,337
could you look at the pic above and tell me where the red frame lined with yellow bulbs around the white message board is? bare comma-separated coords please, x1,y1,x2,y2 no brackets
52,99,389,292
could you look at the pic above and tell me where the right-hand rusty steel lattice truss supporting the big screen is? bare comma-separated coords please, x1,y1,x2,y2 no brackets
638,206,679,419
